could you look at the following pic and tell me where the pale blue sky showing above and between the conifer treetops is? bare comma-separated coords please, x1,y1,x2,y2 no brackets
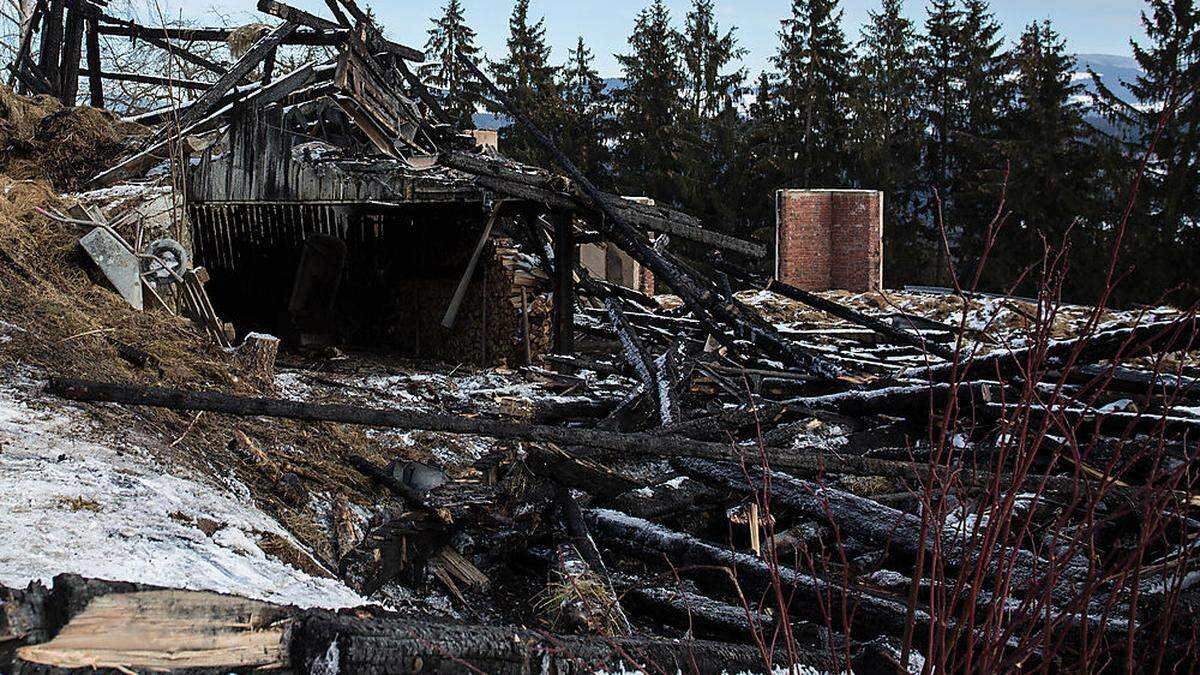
164,0,1146,77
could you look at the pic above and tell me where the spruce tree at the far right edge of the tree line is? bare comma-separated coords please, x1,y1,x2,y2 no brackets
1092,0,1200,303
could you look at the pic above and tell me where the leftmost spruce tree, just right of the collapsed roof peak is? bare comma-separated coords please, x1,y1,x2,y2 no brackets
419,0,482,129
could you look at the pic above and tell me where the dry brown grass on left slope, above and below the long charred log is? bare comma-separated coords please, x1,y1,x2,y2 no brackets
0,165,386,564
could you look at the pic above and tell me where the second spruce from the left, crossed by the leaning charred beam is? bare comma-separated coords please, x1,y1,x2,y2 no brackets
491,0,560,165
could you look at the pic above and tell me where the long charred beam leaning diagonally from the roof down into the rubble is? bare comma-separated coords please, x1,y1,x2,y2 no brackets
458,54,842,380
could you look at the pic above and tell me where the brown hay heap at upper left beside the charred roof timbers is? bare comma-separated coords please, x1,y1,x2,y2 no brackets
0,86,146,191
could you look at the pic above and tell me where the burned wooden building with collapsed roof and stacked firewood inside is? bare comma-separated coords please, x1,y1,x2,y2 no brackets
13,0,792,370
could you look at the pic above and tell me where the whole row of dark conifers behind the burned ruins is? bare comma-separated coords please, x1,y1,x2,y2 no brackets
421,0,1200,304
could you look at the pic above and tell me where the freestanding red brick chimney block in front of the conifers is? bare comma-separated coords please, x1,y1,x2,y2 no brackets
775,190,883,292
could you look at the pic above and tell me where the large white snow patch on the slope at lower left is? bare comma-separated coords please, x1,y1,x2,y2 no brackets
0,365,366,609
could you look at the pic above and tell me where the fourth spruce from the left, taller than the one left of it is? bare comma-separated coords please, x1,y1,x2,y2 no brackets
617,0,684,204
